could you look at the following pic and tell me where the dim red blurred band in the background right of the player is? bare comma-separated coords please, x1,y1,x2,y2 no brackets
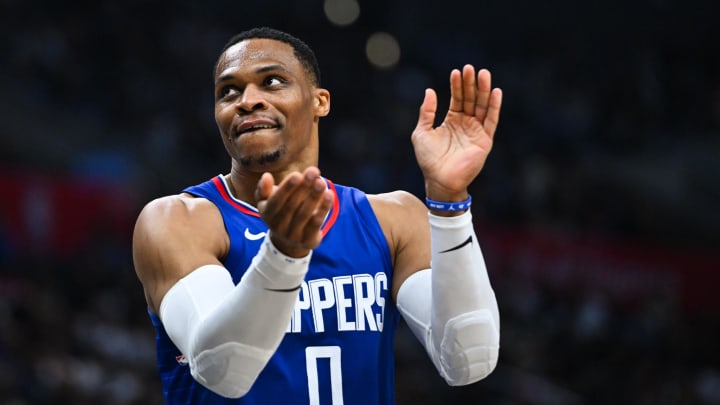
478,229,720,313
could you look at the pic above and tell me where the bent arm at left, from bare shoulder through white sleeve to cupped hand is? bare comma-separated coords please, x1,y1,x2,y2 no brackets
133,169,332,398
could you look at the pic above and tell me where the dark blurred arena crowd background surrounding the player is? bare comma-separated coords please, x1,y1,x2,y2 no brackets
0,0,720,405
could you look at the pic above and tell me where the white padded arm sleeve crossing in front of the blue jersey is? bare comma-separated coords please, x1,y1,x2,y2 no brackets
159,236,312,398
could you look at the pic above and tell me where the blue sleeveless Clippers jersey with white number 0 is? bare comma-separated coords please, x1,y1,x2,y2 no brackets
149,176,399,405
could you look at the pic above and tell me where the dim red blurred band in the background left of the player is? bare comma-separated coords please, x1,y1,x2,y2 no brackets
0,174,136,255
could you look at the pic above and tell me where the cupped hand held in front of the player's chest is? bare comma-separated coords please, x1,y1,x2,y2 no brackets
255,167,333,257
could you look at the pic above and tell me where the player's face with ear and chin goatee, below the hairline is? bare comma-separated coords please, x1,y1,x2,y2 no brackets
215,39,329,171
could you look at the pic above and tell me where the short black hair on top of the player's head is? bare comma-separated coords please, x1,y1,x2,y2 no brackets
215,27,320,87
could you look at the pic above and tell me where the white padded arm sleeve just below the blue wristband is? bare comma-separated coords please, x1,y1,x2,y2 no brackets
397,211,500,385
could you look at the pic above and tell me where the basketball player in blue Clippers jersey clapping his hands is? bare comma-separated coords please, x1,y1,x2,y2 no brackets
133,28,502,405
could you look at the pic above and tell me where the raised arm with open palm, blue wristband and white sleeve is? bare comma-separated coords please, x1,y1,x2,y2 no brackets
397,65,502,385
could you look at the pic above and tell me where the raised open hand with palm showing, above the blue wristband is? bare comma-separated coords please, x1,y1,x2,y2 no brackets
412,65,502,201
